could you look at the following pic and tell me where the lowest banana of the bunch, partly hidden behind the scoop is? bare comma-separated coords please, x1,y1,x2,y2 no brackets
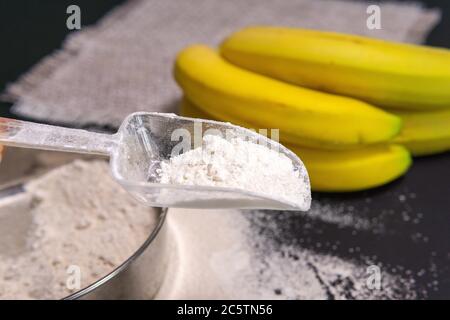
181,98,411,192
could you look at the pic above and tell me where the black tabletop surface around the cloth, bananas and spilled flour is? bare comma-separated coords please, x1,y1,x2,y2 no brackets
0,0,450,299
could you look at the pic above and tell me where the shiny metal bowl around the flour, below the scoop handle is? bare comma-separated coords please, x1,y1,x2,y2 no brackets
0,148,170,300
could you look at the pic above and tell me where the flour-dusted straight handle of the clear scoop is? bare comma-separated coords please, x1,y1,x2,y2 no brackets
0,117,116,156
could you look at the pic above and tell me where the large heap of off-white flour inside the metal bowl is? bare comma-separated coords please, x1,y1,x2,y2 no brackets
0,160,158,299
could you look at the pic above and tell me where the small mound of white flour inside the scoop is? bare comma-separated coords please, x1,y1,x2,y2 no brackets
159,135,311,210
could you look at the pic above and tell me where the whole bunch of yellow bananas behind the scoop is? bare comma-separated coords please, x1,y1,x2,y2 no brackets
174,27,450,191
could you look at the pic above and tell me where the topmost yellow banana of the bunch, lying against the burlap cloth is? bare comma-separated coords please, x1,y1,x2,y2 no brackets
221,27,450,110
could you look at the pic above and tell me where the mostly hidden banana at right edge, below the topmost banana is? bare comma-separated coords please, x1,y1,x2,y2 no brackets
392,110,450,156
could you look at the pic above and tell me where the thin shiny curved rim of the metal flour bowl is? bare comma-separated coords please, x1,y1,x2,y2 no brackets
61,207,168,300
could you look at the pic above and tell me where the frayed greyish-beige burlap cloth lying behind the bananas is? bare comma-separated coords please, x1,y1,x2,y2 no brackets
3,0,440,126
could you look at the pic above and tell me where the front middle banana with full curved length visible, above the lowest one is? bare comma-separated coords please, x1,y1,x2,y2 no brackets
174,45,401,149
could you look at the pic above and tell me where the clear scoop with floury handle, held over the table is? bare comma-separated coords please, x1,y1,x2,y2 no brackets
0,112,311,211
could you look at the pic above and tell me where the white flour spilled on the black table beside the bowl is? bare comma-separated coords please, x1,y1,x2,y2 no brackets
157,209,415,299
